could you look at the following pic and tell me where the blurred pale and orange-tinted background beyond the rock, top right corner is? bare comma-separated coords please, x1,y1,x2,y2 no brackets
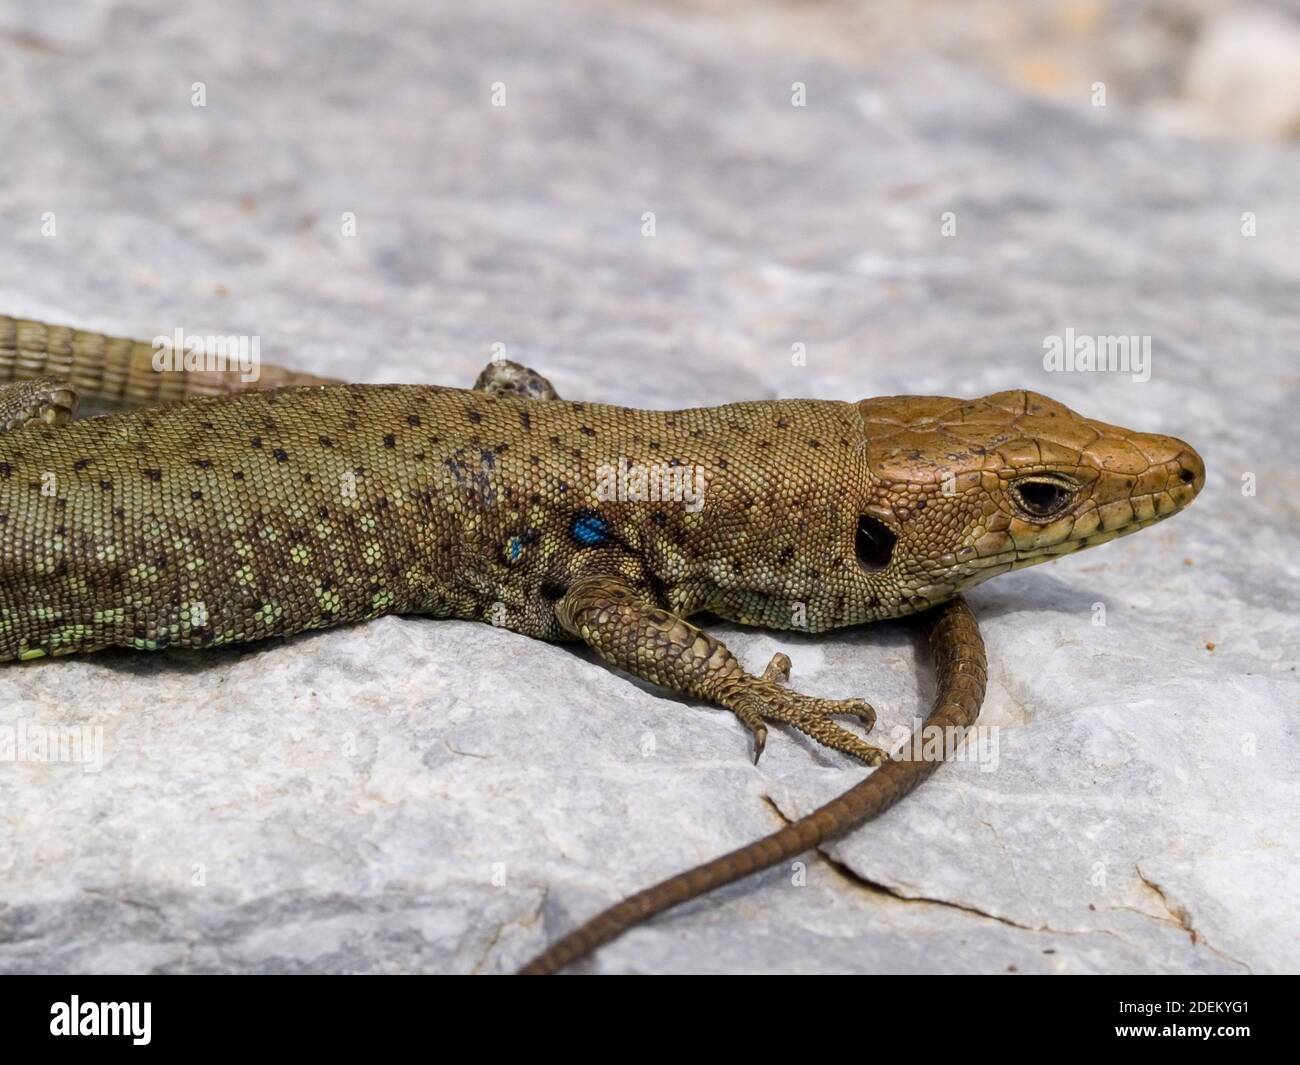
683,0,1300,139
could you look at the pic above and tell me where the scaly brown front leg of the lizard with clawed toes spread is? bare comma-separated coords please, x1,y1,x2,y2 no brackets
556,576,888,766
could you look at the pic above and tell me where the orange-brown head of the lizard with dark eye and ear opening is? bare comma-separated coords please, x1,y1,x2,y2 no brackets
855,391,1205,609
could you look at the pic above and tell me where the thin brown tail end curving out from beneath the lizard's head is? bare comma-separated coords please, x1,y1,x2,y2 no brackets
519,598,988,975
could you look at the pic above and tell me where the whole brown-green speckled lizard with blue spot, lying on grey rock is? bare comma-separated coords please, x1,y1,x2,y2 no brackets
0,317,1205,973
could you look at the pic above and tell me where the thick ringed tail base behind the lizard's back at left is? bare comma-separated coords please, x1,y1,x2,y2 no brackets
0,315,334,407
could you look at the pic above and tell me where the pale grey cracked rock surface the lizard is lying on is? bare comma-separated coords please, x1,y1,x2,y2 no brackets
0,0,1300,973
